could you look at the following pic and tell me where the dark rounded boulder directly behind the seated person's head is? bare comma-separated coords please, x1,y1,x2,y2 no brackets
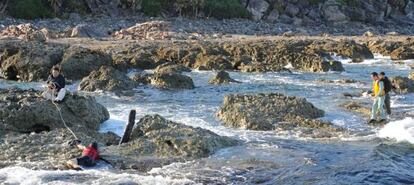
61,46,111,80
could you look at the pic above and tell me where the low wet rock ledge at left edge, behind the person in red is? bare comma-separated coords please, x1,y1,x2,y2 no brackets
0,128,119,170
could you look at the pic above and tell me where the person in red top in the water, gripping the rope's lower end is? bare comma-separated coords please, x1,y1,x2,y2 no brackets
66,140,99,170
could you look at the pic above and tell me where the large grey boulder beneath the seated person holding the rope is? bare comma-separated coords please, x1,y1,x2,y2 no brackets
0,89,109,133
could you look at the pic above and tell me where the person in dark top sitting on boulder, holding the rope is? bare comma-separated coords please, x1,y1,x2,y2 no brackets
42,66,66,103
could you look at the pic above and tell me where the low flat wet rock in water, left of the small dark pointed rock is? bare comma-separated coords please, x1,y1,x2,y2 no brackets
151,73,194,90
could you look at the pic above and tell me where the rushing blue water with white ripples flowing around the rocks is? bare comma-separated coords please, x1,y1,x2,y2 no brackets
0,56,414,184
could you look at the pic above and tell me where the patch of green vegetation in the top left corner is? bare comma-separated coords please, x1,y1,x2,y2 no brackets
8,0,53,19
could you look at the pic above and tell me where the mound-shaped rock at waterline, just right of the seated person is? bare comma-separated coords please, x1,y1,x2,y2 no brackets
79,66,137,92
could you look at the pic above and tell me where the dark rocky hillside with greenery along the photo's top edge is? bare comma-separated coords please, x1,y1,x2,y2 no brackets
0,0,414,25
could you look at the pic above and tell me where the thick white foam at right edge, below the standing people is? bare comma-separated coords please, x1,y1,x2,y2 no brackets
378,118,414,144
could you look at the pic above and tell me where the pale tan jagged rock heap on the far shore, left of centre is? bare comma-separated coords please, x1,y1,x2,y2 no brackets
114,21,170,40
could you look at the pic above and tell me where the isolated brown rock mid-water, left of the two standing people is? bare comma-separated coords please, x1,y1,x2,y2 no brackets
216,93,324,130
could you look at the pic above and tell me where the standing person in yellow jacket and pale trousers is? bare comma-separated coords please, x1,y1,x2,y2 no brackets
369,72,385,123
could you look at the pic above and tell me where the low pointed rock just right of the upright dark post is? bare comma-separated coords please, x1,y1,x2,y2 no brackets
102,115,238,171
